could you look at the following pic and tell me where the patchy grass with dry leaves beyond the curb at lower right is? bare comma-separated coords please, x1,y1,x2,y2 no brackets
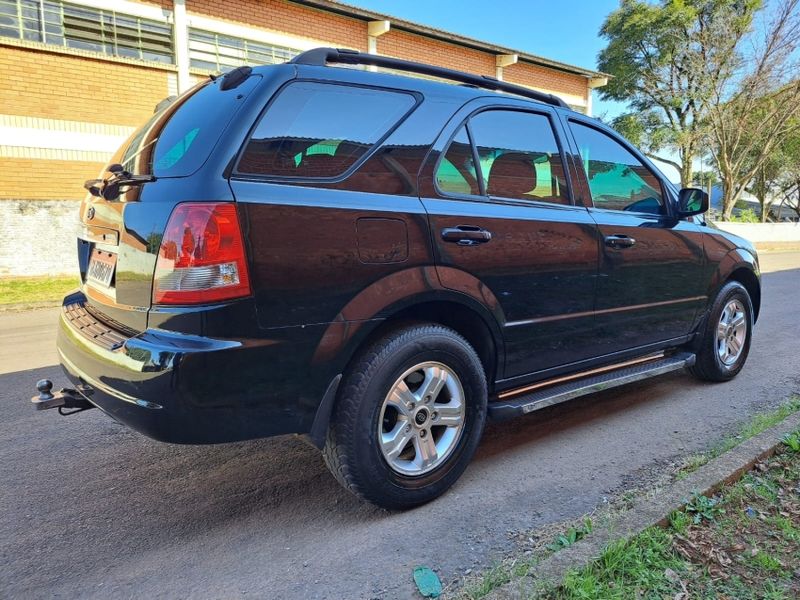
541,434,800,600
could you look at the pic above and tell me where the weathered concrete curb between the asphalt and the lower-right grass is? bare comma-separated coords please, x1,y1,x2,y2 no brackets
488,413,800,600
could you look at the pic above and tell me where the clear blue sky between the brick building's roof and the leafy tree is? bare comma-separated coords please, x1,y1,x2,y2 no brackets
344,0,625,120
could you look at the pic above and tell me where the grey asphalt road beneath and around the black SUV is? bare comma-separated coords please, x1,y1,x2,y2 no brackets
0,254,800,599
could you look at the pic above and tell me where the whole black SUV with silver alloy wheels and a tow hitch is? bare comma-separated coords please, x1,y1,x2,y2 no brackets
34,48,760,508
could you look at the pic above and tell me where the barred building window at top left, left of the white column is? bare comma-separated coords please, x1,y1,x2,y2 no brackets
0,0,174,64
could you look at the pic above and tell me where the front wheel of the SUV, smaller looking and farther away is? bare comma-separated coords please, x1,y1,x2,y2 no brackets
690,281,753,381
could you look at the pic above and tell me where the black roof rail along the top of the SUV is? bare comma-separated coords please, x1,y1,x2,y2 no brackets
289,48,569,108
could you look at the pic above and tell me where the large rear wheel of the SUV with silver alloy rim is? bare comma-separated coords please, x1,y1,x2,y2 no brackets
323,324,487,509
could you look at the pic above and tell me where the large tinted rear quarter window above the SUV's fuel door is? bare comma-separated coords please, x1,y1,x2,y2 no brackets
239,82,415,177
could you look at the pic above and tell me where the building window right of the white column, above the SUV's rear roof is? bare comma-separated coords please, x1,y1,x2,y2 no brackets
189,29,300,71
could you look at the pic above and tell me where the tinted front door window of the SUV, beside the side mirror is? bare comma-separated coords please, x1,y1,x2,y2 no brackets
570,123,666,214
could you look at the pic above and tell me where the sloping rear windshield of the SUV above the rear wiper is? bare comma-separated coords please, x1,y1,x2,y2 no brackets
116,75,261,177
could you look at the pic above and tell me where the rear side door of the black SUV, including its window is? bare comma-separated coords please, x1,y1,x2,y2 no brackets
421,107,599,378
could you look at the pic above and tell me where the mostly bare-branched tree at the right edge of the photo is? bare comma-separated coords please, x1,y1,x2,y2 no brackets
687,0,800,220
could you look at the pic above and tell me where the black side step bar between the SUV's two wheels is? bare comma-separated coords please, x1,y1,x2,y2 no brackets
488,352,695,420
